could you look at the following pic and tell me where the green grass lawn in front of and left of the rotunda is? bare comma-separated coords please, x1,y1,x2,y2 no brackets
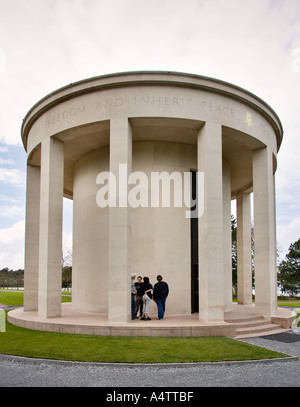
0,290,292,363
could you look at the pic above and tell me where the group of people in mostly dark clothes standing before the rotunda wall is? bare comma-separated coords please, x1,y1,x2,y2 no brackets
131,273,169,321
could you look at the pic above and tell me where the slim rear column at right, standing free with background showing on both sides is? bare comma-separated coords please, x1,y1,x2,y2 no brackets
236,193,252,305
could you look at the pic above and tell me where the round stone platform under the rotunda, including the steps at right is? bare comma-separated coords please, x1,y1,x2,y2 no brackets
7,303,294,338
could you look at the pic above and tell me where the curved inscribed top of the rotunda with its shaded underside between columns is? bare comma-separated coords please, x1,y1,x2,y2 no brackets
22,72,283,201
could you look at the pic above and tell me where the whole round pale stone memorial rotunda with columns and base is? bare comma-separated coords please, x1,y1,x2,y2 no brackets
9,71,296,336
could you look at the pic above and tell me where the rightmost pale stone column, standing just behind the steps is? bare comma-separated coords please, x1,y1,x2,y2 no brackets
253,147,277,317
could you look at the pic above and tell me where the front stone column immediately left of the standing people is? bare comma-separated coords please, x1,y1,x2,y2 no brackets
108,118,132,323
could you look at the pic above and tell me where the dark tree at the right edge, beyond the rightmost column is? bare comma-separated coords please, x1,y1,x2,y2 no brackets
278,239,300,296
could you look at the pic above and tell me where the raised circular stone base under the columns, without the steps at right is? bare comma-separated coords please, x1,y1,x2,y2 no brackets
7,303,235,337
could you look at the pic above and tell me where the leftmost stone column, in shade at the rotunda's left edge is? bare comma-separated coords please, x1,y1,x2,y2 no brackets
24,164,40,311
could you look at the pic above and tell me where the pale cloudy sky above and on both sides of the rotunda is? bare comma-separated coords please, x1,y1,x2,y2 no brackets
0,0,300,269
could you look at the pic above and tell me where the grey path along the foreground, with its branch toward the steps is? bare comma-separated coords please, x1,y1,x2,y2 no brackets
0,331,300,390
